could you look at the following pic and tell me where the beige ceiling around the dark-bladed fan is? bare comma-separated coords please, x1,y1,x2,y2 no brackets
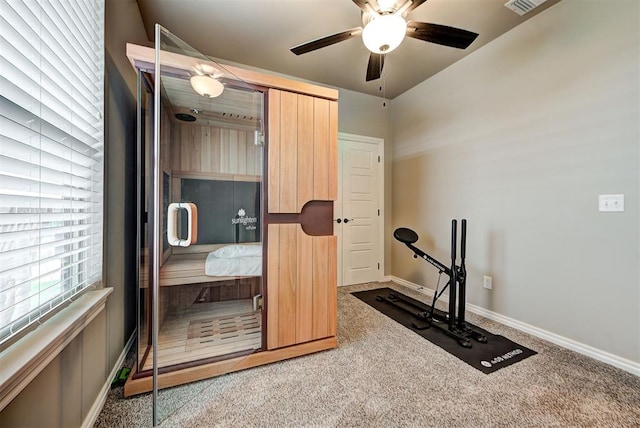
137,0,560,99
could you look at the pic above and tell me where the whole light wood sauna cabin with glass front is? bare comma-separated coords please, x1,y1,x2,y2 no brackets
124,44,338,396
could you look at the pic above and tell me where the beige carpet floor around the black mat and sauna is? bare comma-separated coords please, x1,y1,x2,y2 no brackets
95,283,640,427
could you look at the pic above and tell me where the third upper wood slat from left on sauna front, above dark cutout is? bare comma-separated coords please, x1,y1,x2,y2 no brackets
295,95,315,212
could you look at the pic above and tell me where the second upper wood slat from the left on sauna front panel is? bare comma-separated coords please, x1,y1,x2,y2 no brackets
282,92,298,213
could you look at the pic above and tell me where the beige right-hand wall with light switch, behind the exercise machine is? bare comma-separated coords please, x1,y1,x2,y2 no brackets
392,0,640,362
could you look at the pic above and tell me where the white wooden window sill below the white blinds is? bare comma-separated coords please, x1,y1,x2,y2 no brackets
0,288,112,411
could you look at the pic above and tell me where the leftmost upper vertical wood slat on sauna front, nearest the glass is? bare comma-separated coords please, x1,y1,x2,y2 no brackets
267,89,282,213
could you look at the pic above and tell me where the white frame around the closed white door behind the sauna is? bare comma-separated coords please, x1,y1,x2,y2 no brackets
334,132,385,287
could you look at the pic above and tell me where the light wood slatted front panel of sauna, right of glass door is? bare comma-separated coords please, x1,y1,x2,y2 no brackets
267,90,338,349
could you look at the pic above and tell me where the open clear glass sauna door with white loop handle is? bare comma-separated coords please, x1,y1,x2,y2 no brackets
151,26,264,423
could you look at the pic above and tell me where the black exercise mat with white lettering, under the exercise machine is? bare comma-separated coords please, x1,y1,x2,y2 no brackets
351,288,537,374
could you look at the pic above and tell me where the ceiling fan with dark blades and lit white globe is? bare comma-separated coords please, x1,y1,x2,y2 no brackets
290,0,478,82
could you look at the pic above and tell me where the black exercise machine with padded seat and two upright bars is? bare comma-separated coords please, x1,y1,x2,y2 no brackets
384,219,487,348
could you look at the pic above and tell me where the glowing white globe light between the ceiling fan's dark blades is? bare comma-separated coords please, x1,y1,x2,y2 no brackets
362,14,407,54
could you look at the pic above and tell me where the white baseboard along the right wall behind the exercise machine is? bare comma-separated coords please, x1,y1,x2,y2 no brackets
385,275,640,376
